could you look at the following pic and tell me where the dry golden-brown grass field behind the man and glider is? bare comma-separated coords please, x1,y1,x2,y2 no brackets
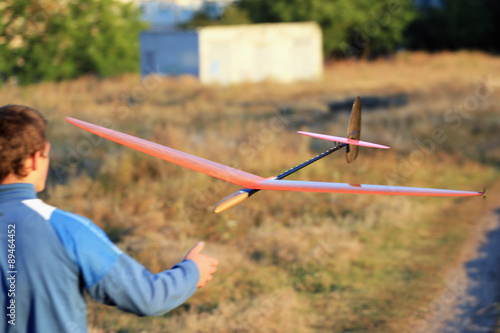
0,52,500,333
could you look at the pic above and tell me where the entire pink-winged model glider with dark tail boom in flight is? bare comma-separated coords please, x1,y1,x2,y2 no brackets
66,97,484,213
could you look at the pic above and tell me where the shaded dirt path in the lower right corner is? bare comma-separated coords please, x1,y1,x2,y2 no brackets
420,208,500,333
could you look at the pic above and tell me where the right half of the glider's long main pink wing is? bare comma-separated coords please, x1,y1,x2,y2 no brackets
252,179,483,197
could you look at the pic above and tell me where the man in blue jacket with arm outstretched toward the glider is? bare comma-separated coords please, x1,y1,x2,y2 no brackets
0,105,218,333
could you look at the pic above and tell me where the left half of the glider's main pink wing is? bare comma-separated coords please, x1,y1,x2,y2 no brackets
66,117,264,187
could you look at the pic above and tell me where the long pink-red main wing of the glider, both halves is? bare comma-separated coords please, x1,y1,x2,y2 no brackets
66,117,483,196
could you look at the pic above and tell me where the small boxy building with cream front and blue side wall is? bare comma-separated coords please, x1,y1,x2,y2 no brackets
140,22,323,84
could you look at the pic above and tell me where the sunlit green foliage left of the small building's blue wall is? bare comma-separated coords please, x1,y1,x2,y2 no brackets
0,0,144,83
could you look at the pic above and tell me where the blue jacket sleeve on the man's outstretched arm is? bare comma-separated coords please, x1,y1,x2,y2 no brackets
50,210,199,316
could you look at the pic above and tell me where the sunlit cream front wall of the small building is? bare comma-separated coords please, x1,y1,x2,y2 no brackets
199,22,323,84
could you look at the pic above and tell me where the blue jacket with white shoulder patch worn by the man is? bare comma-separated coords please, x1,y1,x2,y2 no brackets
0,184,199,333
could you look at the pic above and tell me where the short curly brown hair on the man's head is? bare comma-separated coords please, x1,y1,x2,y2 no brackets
0,105,47,181
